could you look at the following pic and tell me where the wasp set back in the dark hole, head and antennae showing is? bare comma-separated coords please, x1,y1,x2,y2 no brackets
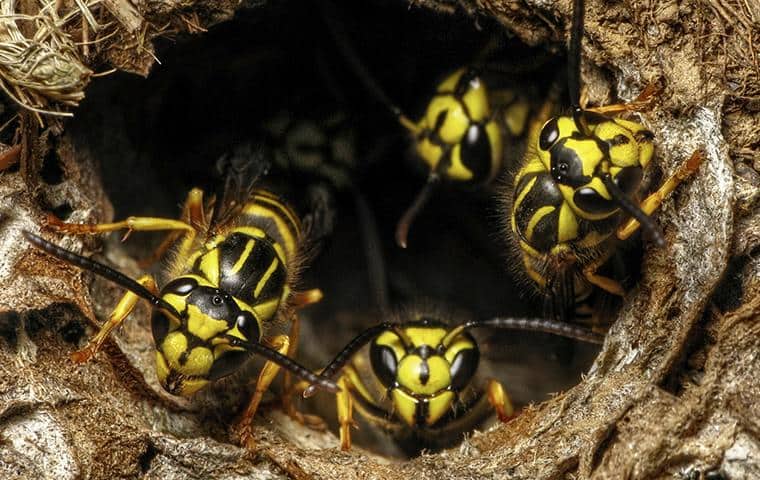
320,2,530,248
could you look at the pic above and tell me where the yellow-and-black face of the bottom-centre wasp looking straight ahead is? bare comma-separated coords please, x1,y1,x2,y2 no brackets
370,321,479,427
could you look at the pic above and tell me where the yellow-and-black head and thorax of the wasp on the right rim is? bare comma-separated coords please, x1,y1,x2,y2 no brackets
511,112,653,253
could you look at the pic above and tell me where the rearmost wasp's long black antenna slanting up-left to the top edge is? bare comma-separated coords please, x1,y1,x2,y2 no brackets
317,0,419,134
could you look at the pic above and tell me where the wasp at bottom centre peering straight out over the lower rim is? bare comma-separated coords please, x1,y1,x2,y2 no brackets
304,313,602,450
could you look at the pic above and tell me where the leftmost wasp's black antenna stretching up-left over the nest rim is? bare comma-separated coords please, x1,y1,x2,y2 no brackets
21,230,180,318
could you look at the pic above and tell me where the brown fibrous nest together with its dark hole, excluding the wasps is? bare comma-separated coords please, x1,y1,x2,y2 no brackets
0,0,760,479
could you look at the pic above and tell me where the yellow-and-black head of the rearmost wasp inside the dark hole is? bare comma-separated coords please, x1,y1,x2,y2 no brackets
416,69,503,185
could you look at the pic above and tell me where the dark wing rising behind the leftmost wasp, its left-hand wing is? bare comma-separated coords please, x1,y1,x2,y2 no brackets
208,143,271,236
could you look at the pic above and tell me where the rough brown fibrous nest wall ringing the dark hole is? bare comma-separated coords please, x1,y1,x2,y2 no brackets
0,0,760,480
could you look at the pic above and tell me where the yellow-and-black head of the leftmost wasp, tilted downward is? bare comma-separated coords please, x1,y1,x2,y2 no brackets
151,275,262,396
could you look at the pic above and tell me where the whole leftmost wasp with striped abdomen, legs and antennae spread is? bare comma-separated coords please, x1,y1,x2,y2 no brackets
25,145,337,443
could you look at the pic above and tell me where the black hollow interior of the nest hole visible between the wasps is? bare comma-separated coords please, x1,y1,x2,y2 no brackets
67,3,597,454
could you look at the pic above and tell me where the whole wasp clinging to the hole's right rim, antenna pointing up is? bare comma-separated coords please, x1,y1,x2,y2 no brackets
506,0,702,319
